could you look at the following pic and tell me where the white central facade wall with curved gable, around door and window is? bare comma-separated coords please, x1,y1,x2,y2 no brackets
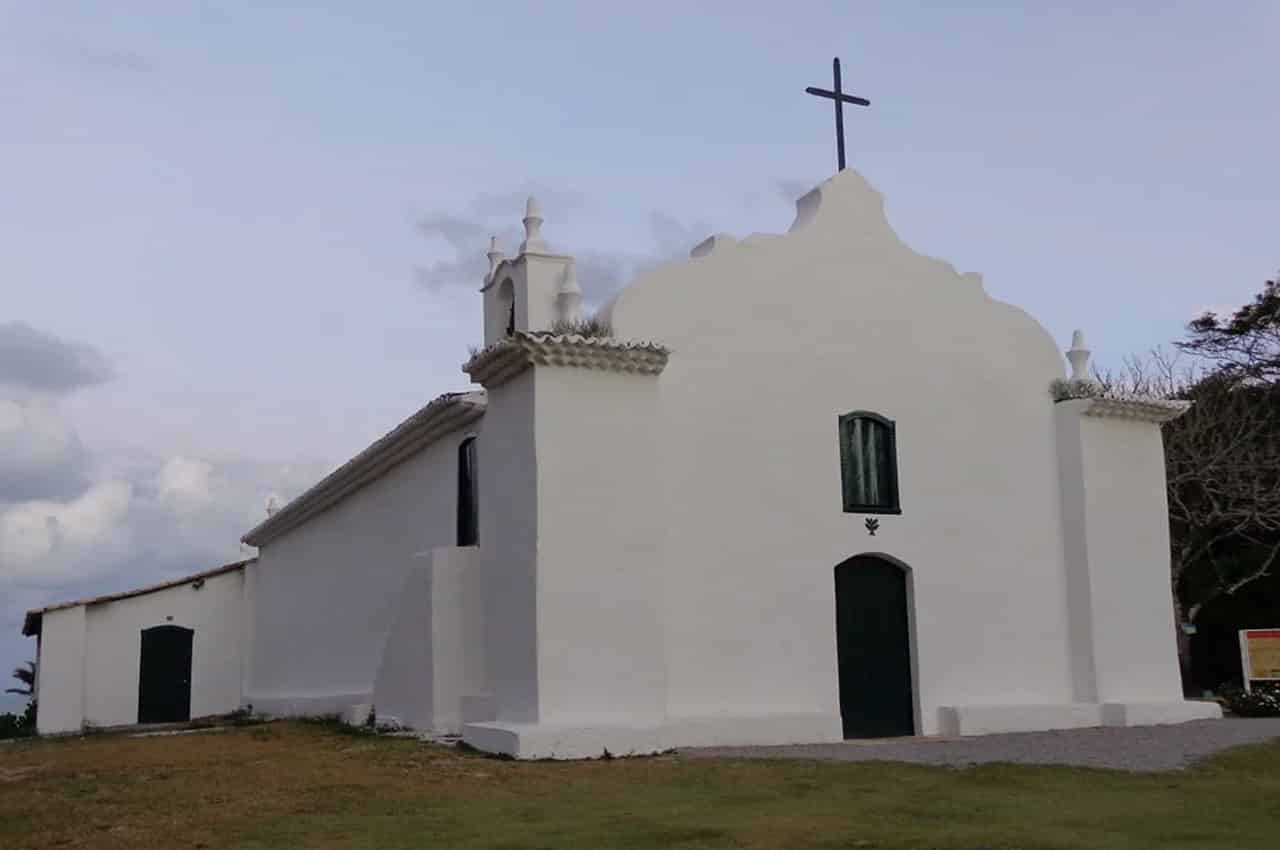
607,172,1073,732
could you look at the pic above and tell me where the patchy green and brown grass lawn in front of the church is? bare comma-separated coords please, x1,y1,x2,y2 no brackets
0,723,1280,850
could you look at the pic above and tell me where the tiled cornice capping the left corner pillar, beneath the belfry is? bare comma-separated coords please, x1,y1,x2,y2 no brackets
462,332,671,388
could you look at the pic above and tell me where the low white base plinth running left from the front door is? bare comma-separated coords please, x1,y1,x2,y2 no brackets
462,714,841,759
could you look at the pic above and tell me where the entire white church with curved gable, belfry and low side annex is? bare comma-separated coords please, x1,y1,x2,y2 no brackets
24,170,1220,758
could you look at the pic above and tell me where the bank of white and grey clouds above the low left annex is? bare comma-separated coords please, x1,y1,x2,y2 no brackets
0,324,324,696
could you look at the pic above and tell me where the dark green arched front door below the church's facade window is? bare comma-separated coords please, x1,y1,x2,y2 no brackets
836,556,915,737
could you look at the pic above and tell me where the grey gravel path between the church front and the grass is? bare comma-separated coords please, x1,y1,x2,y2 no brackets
680,717,1280,771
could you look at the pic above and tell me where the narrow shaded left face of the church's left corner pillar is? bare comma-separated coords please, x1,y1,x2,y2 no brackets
479,370,541,723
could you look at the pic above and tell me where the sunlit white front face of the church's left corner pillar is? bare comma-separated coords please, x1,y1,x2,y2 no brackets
535,367,667,723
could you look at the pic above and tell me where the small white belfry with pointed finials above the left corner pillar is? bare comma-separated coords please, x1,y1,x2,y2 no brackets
480,197,582,347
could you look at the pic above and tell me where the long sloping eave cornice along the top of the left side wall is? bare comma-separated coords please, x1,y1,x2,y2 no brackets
241,390,485,547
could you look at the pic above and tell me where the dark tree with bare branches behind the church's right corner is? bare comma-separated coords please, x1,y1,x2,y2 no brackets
1098,272,1280,690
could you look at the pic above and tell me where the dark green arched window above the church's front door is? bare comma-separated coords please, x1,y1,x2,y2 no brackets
840,411,902,513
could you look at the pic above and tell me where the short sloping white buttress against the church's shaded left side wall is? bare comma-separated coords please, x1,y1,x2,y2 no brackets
374,547,486,734
